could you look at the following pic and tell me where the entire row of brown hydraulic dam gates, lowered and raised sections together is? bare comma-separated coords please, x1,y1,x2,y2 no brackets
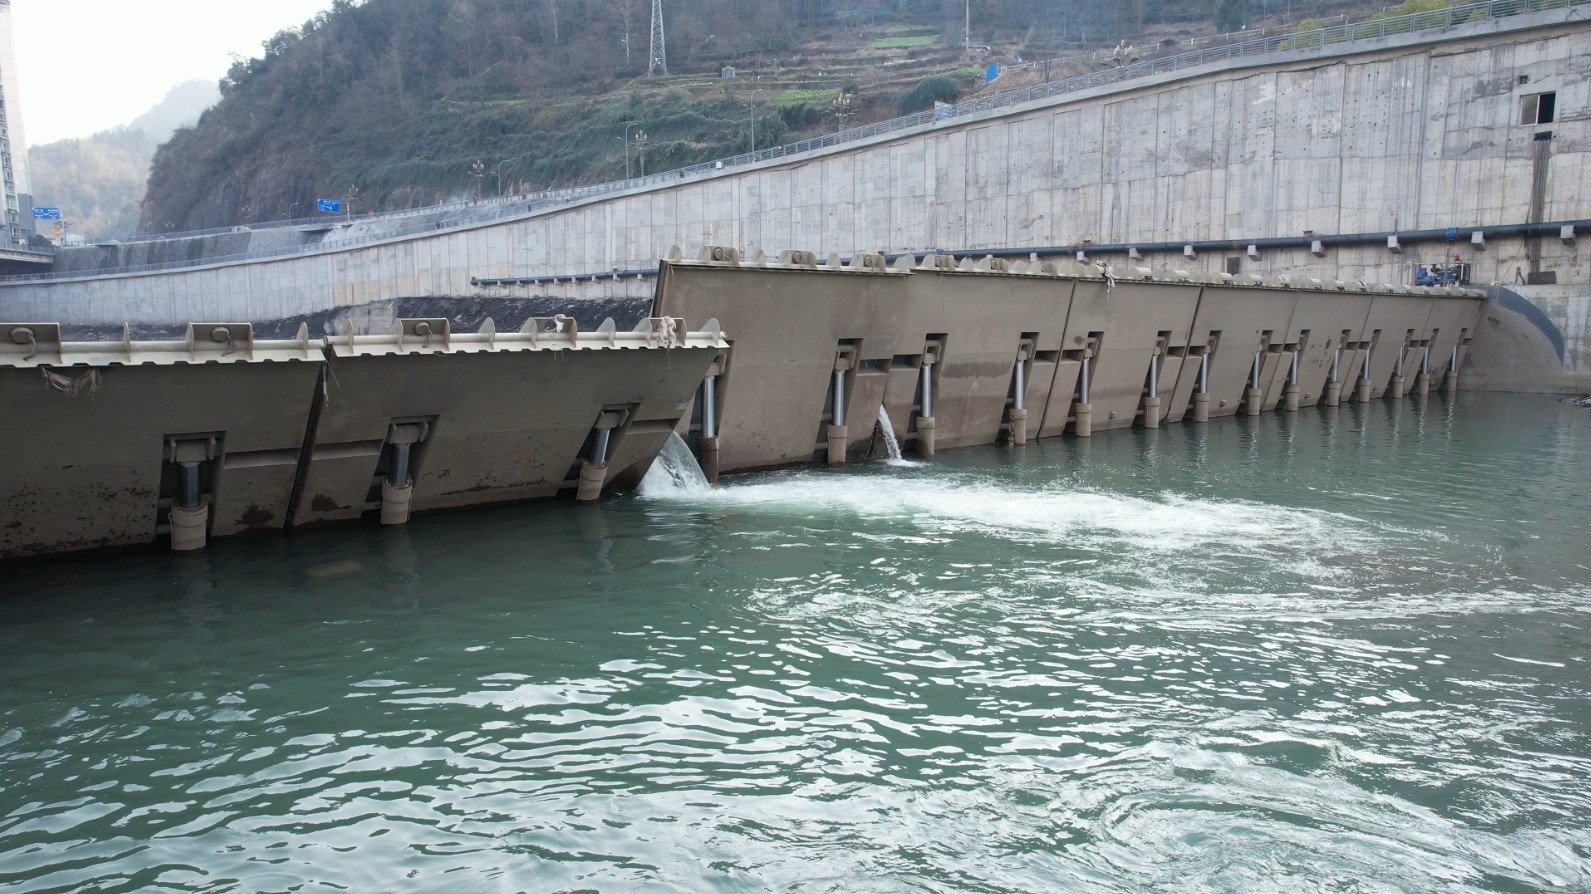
0,260,1484,560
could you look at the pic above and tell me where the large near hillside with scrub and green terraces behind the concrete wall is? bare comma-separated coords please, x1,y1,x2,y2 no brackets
140,0,1380,232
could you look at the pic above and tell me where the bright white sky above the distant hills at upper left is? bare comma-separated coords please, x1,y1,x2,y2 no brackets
11,0,331,145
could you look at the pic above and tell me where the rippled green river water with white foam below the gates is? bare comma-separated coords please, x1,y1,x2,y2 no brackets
0,395,1591,894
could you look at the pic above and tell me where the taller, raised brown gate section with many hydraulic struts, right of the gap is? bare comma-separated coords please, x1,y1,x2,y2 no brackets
652,247,1484,479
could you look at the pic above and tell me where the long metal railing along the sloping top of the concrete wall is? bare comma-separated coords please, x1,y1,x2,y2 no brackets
9,0,1591,282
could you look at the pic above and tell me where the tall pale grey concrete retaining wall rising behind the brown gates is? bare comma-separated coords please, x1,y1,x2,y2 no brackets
0,8,1591,388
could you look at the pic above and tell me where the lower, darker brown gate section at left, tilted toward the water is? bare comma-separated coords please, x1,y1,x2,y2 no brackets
0,317,727,560
